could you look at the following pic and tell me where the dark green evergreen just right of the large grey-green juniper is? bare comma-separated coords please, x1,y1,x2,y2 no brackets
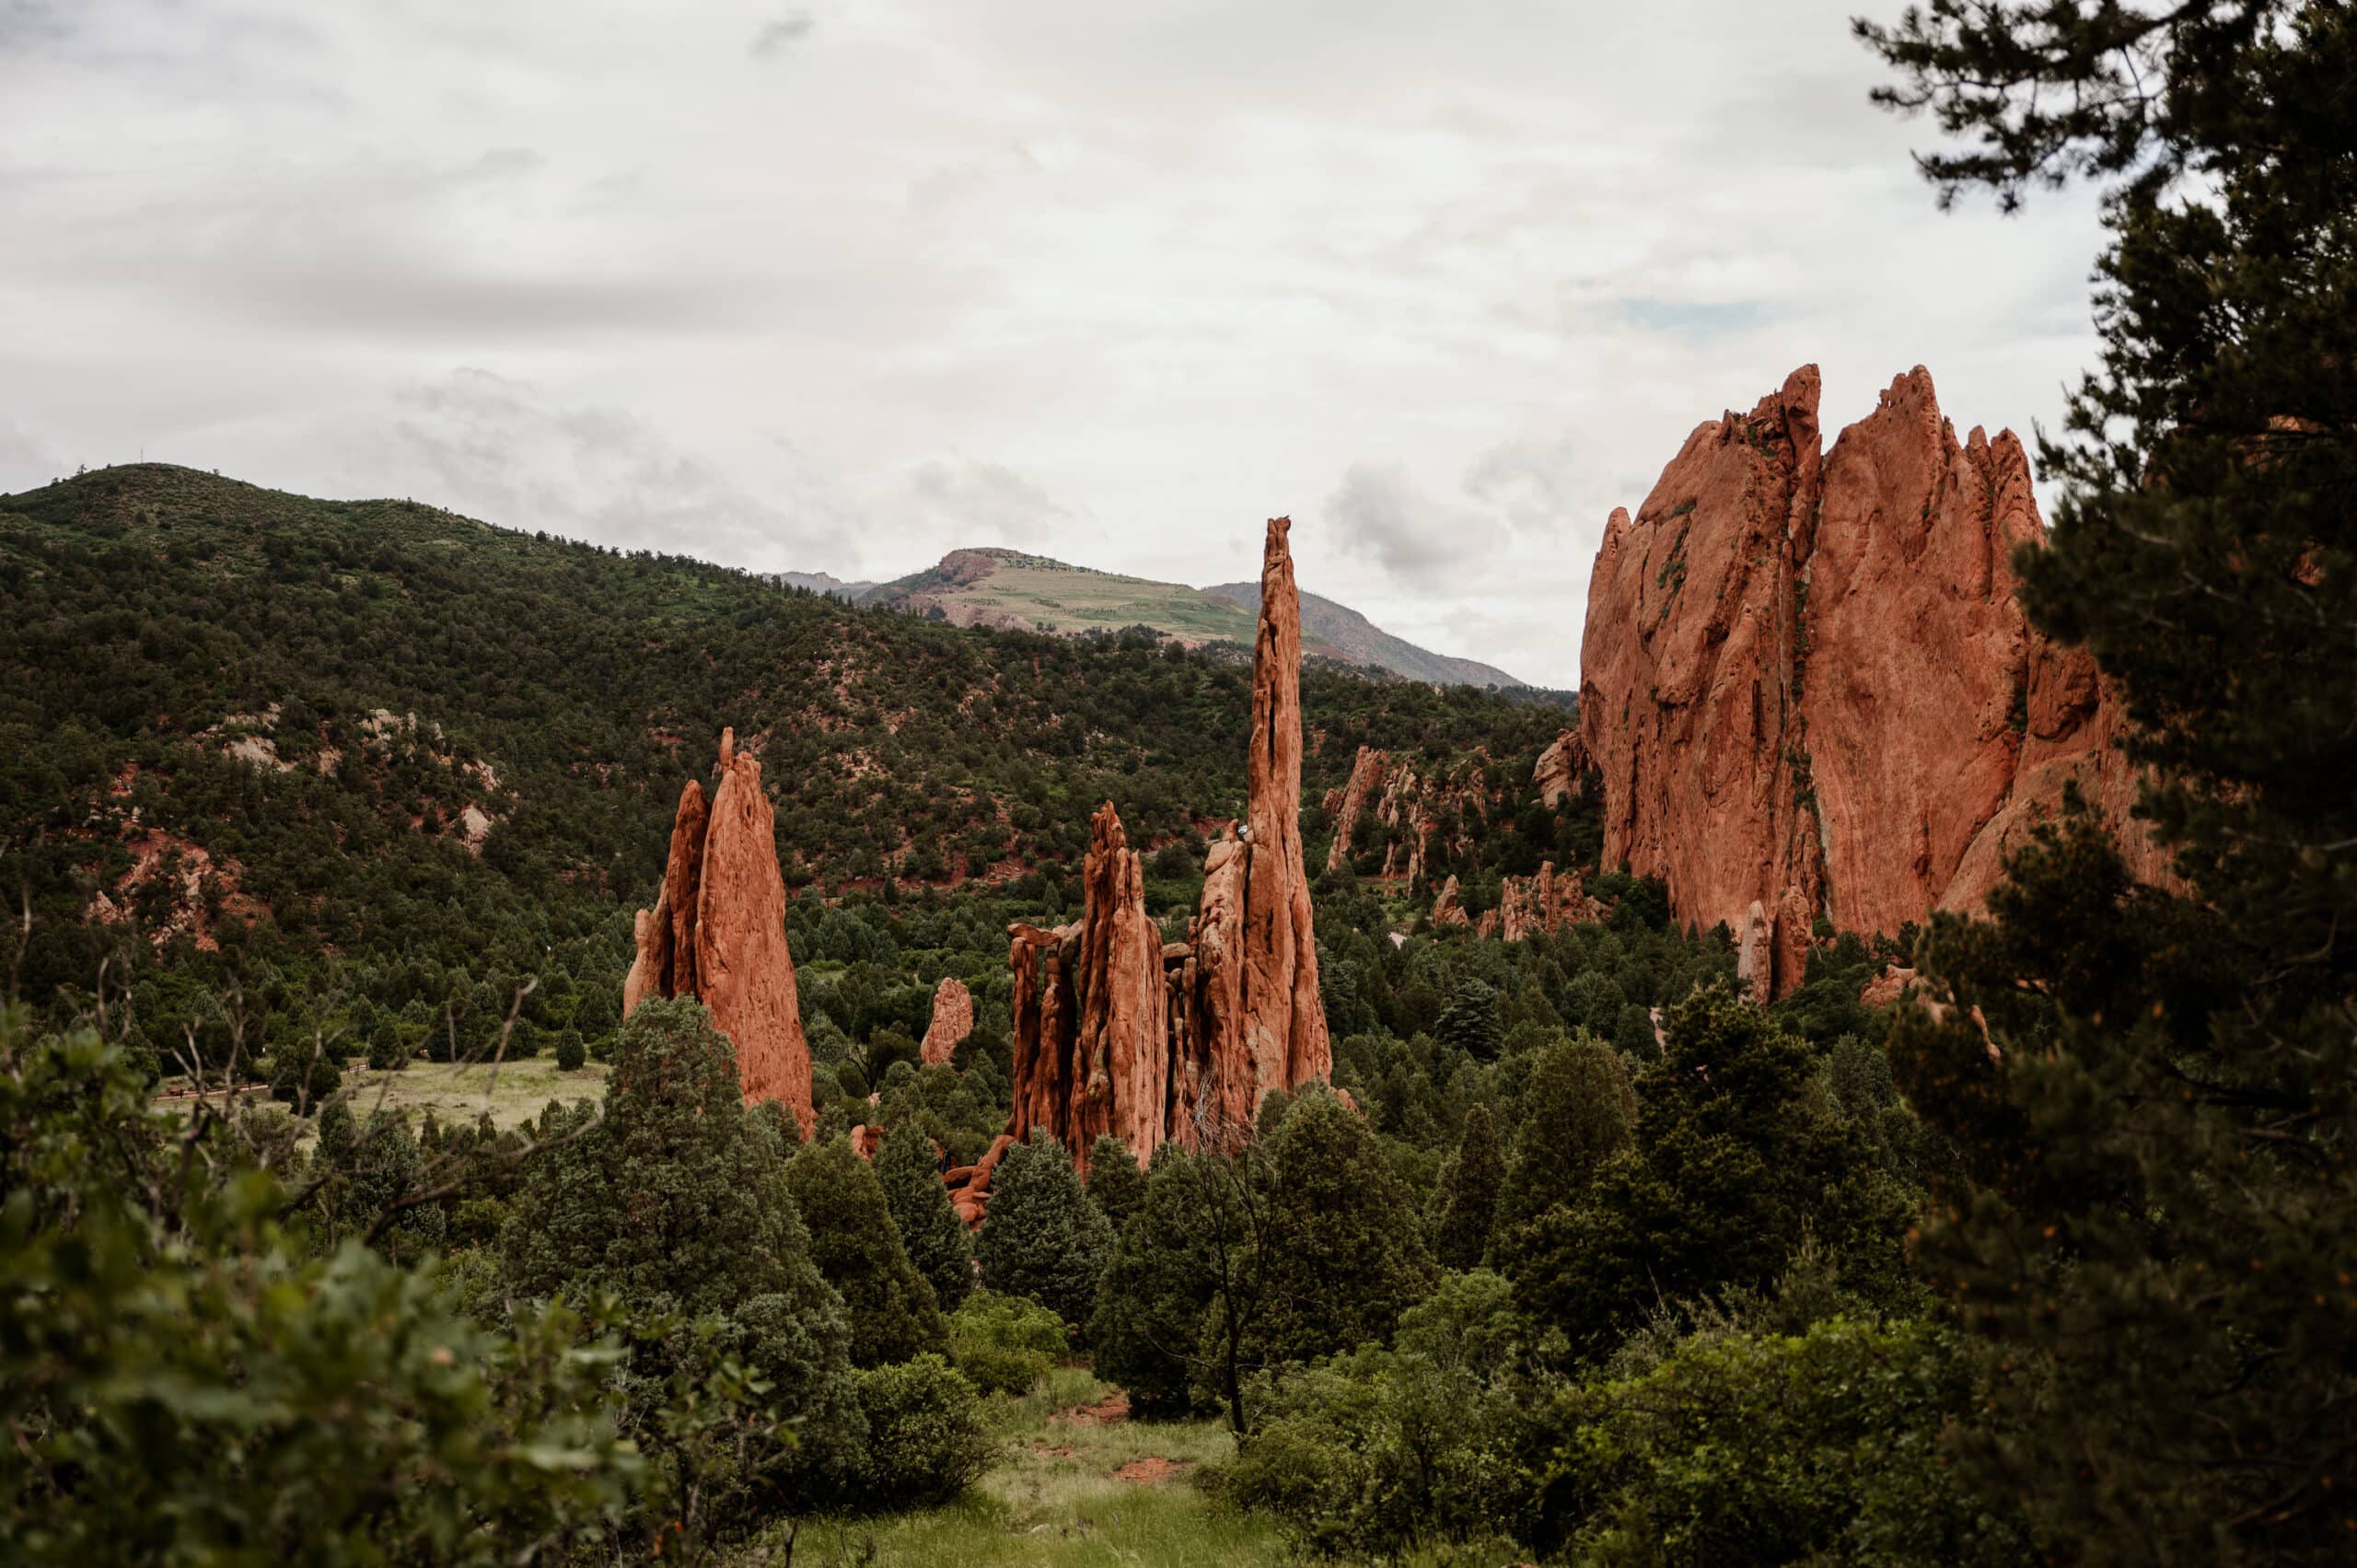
784,1139,950,1367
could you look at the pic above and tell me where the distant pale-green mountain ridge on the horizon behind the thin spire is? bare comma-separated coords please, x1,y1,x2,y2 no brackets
860,550,1520,686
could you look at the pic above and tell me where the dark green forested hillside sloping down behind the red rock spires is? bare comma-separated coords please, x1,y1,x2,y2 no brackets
0,464,1567,1074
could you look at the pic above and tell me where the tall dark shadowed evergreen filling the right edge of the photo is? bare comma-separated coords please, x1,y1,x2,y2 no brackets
1862,0,2357,1561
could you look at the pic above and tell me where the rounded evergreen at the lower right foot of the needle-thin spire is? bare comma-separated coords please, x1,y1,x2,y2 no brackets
1256,1089,1433,1363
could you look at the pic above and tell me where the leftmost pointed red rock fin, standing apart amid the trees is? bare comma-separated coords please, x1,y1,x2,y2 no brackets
622,728,818,1136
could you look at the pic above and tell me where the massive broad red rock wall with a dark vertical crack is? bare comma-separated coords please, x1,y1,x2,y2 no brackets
1579,366,2164,995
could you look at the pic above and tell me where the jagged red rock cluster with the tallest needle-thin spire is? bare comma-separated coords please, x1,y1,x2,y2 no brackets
999,518,1339,1169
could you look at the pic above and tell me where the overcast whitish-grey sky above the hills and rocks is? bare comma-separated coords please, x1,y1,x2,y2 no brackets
0,0,2103,686
